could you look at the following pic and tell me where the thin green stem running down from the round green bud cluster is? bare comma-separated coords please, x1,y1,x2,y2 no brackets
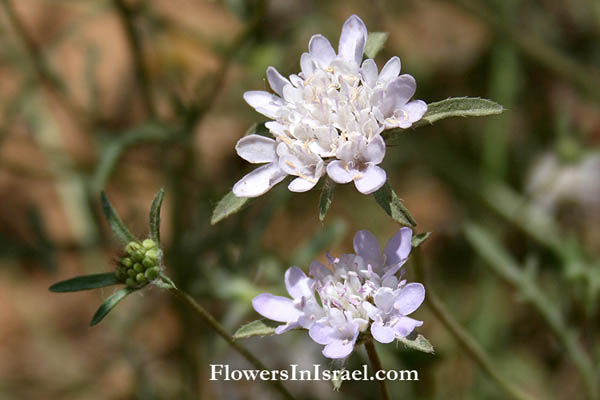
168,283,294,400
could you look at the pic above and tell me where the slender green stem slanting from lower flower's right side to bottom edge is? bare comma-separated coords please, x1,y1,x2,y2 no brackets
413,247,531,400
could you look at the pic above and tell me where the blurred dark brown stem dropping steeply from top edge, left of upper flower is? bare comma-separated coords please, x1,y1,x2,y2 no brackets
113,0,156,117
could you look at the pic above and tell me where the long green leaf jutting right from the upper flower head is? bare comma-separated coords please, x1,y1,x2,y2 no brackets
383,97,504,145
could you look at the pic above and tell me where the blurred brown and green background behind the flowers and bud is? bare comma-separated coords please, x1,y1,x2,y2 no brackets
0,0,600,399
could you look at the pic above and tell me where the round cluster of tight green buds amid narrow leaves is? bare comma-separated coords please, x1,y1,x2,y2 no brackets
115,239,161,288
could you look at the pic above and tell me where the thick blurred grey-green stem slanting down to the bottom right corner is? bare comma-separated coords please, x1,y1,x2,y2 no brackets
465,224,599,399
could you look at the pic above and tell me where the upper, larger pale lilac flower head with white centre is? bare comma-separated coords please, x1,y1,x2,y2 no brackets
233,15,427,197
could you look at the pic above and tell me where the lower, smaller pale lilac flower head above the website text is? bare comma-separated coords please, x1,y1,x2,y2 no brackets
252,228,425,358
